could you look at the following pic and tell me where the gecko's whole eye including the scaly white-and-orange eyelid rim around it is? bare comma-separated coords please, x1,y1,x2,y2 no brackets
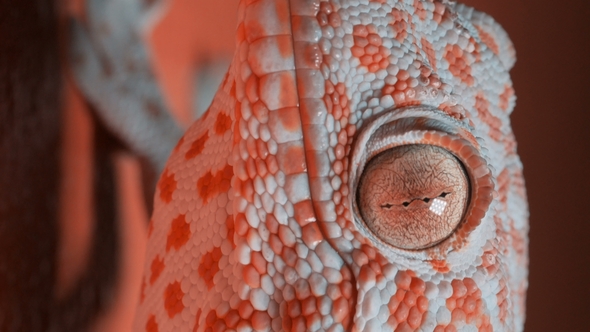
349,105,494,255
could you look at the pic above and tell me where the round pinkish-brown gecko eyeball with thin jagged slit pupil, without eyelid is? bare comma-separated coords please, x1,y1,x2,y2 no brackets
357,144,469,249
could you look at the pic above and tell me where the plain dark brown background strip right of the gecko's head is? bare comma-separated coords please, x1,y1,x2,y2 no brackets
461,0,590,332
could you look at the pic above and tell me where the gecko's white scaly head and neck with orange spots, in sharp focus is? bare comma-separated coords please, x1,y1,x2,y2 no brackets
135,0,528,332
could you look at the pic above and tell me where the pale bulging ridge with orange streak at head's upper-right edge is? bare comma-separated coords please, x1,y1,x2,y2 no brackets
455,4,516,70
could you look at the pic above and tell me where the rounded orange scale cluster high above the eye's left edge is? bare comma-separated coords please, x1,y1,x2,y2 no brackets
351,24,391,73
